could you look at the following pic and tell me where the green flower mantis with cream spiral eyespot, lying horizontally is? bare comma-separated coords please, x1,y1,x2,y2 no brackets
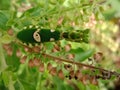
17,25,89,44
